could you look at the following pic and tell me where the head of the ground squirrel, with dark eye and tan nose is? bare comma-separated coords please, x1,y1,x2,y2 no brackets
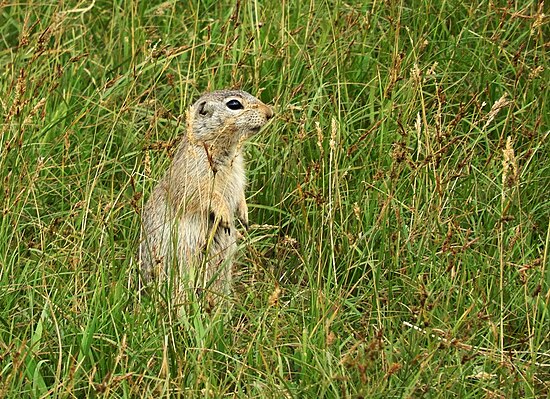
191,90,273,146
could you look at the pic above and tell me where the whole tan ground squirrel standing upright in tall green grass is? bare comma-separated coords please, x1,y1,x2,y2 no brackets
139,90,273,304
